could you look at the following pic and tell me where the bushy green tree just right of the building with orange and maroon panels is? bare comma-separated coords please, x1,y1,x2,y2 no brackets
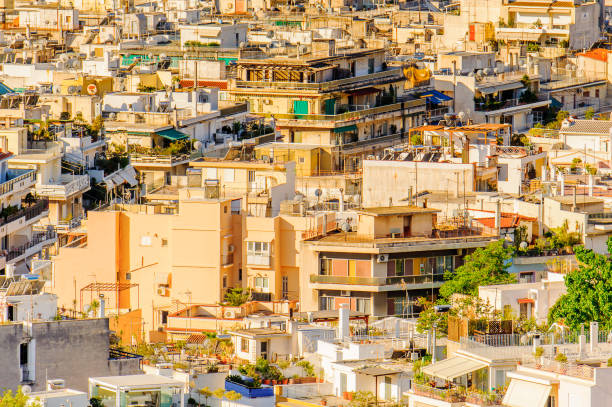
440,240,515,298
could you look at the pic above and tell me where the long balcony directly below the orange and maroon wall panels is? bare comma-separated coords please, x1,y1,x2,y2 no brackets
310,274,444,291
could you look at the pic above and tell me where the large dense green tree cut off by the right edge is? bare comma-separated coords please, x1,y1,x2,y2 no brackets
548,237,612,329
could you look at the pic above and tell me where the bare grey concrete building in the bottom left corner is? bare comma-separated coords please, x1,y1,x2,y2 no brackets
0,318,140,391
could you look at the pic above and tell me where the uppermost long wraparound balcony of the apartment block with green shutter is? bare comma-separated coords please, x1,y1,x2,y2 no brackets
236,69,405,92
